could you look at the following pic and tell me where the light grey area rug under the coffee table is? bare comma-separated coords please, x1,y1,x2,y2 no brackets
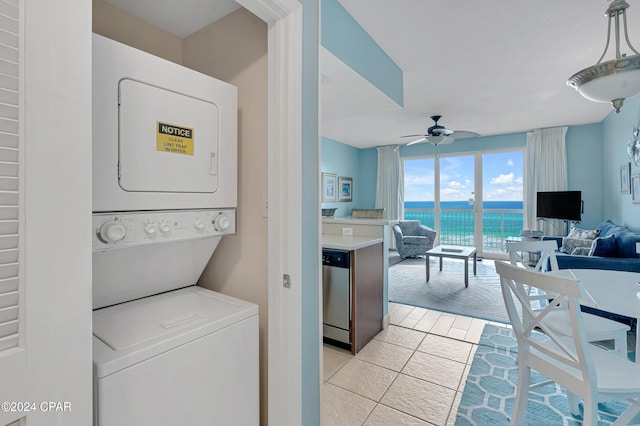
389,258,509,323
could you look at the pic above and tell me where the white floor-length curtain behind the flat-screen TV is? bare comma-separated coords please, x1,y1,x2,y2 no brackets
524,127,567,235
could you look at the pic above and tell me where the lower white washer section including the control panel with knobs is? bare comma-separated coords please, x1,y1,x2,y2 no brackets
93,209,260,426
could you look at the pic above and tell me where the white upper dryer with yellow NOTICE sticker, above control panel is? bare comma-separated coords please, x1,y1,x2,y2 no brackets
92,34,238,212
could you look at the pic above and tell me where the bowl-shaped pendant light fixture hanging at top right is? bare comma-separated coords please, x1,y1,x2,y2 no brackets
567,0,640,112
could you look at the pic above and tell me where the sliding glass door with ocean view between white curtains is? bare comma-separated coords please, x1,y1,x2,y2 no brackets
404,151,523,258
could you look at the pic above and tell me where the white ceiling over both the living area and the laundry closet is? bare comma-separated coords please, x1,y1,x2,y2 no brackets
107,0,640,148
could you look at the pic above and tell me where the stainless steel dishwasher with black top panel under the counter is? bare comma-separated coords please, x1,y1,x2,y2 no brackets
322,250,351,346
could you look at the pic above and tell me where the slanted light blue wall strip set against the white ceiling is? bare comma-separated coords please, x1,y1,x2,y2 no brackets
322,0,404,106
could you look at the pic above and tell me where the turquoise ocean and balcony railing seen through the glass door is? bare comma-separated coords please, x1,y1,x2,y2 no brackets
404,208,522,252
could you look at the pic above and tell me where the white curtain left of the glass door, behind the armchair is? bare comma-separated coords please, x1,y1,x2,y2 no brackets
376,145,404,220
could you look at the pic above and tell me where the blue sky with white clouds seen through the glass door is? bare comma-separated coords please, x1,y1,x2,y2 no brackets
404,151,523,201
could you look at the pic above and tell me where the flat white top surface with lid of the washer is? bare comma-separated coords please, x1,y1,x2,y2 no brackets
93,286,257,351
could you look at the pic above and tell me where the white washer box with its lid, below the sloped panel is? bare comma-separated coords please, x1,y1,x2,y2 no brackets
93,286,259,426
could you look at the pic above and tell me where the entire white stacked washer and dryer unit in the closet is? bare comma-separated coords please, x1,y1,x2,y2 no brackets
93,35,259,426
